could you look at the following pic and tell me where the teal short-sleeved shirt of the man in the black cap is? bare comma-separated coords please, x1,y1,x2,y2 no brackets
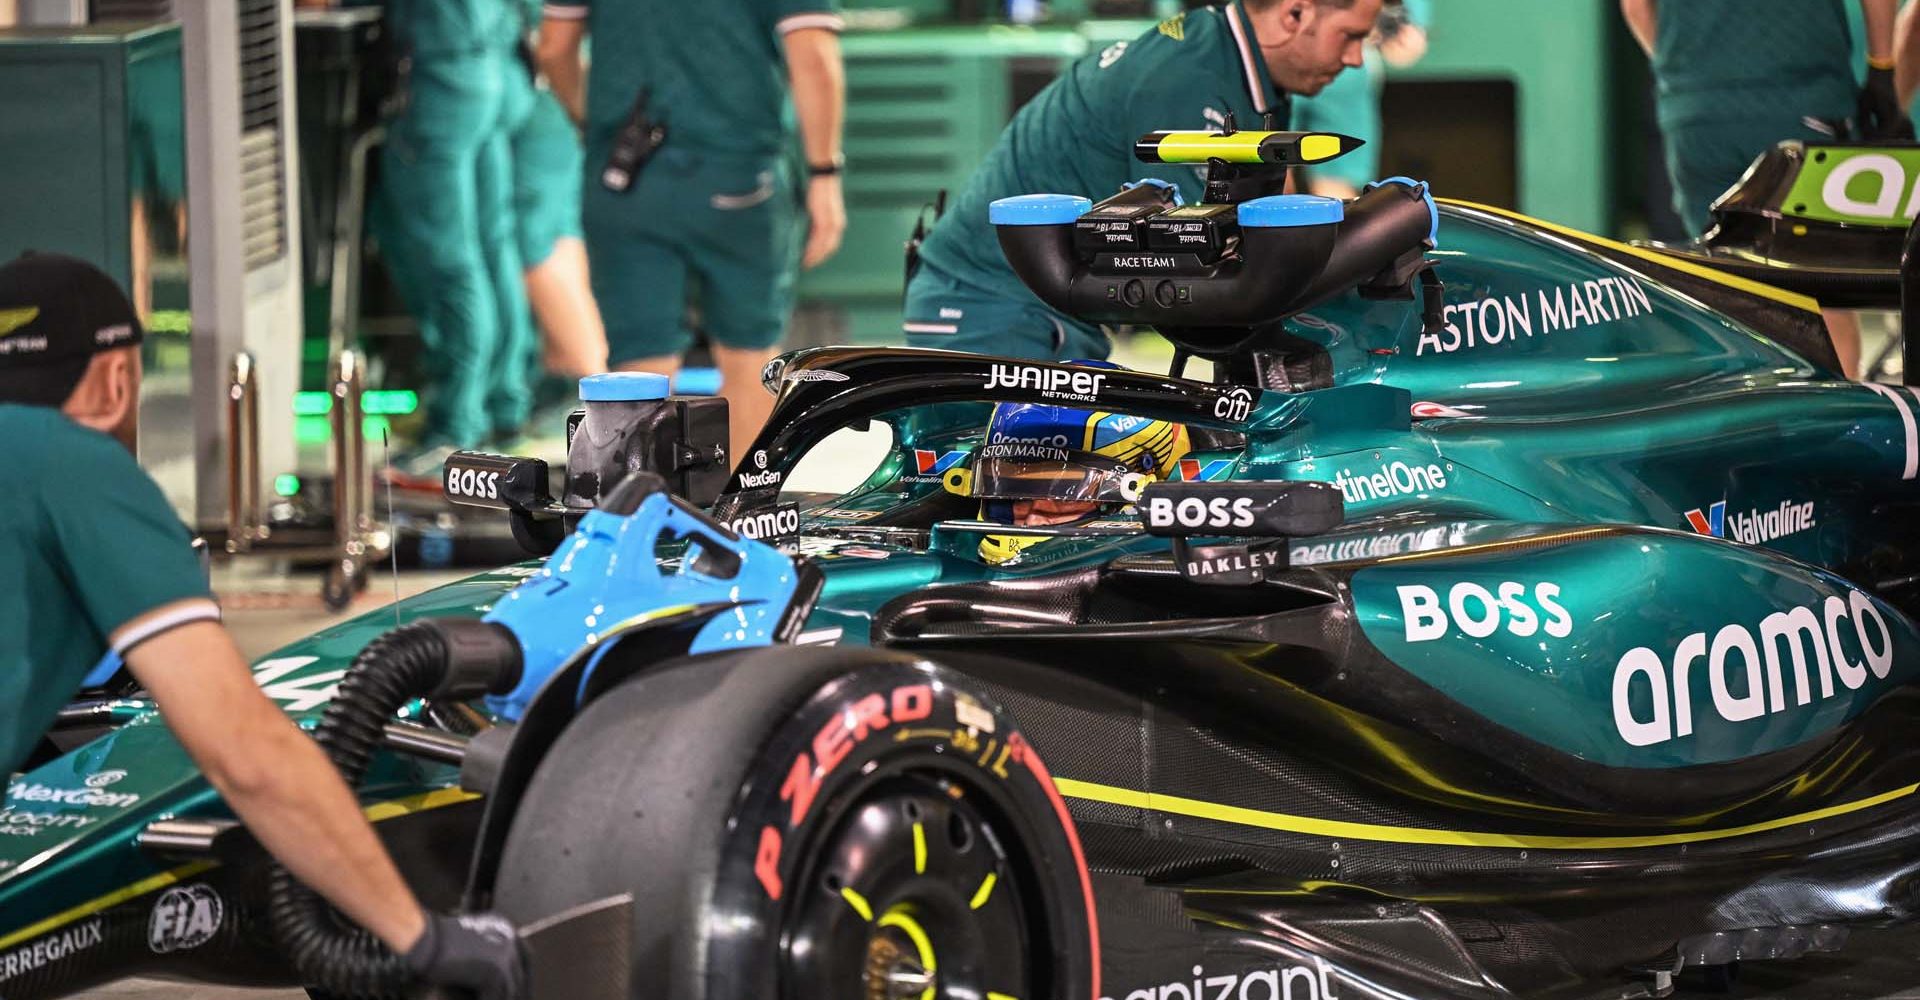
0,403,219,772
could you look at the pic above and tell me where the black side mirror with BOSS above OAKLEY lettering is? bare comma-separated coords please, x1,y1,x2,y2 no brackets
1135,480,1346,585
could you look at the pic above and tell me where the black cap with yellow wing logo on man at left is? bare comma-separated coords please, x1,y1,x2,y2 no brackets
0,253,142,407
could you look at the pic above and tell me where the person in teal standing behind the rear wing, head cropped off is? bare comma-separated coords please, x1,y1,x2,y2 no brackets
1620,0,1912,376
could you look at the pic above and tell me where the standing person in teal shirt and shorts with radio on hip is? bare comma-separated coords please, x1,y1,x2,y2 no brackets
540,0,847,453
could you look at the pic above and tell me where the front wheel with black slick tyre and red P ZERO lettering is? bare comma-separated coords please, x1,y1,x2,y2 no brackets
495,647,1100,1000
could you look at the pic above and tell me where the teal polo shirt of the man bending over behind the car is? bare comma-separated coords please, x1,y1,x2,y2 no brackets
920,0,1288,307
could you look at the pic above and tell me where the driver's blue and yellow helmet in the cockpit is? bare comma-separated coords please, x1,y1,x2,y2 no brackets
964,374,1192,564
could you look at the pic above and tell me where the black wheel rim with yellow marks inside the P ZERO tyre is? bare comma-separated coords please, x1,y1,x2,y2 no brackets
781,768,1046,1000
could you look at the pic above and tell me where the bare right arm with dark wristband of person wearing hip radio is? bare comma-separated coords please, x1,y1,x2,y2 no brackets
781,27,847,267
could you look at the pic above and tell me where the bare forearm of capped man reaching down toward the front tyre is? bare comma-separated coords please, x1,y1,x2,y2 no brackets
121,608,426,954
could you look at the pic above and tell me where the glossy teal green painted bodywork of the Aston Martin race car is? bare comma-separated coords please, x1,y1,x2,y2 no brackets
15,207,1920,948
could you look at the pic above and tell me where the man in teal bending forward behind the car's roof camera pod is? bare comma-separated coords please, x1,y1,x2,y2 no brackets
902,0,1380,359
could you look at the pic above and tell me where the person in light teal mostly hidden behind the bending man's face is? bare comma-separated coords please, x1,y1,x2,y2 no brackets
1294,0,1432,200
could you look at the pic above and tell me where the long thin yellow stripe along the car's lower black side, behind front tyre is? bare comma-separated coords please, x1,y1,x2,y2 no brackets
1054,777,1920,850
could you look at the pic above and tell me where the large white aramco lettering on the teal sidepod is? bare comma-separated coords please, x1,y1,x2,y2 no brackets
1613,589,1893,747
